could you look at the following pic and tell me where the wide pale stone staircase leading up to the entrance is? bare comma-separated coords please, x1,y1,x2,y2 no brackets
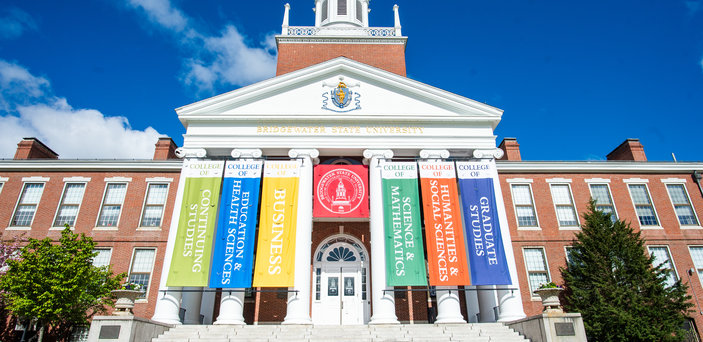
152,323,529,342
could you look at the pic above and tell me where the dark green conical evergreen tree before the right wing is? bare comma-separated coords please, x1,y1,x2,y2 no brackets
561,202,693,341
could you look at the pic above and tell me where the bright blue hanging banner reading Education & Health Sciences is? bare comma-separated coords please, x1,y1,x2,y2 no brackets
210,160,262,288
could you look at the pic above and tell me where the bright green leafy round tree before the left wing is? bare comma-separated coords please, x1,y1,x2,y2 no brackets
0,226,125,340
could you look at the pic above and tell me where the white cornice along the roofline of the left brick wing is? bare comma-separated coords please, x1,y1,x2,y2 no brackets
0,160,183,172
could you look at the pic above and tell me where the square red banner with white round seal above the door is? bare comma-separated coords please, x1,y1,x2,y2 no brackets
313,165,369,218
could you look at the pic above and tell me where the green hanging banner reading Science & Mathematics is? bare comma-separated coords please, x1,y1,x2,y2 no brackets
382,162,427,286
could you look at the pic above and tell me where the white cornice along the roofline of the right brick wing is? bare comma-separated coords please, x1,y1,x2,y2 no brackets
496,161,703,174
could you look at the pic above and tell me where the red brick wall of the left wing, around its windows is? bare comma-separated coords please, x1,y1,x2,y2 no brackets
0,171,180,317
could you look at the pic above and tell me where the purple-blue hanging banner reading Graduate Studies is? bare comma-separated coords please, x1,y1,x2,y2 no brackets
456,161,512,285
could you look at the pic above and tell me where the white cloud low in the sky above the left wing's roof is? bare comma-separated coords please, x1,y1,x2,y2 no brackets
0,60,160,159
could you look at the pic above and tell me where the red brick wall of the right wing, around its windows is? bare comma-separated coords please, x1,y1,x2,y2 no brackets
500,173,703,329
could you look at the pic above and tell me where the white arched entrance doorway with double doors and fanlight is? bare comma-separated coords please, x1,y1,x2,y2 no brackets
312,234,371,325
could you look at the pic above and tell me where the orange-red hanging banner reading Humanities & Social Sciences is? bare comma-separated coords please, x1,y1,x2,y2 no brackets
418,162,471,286
